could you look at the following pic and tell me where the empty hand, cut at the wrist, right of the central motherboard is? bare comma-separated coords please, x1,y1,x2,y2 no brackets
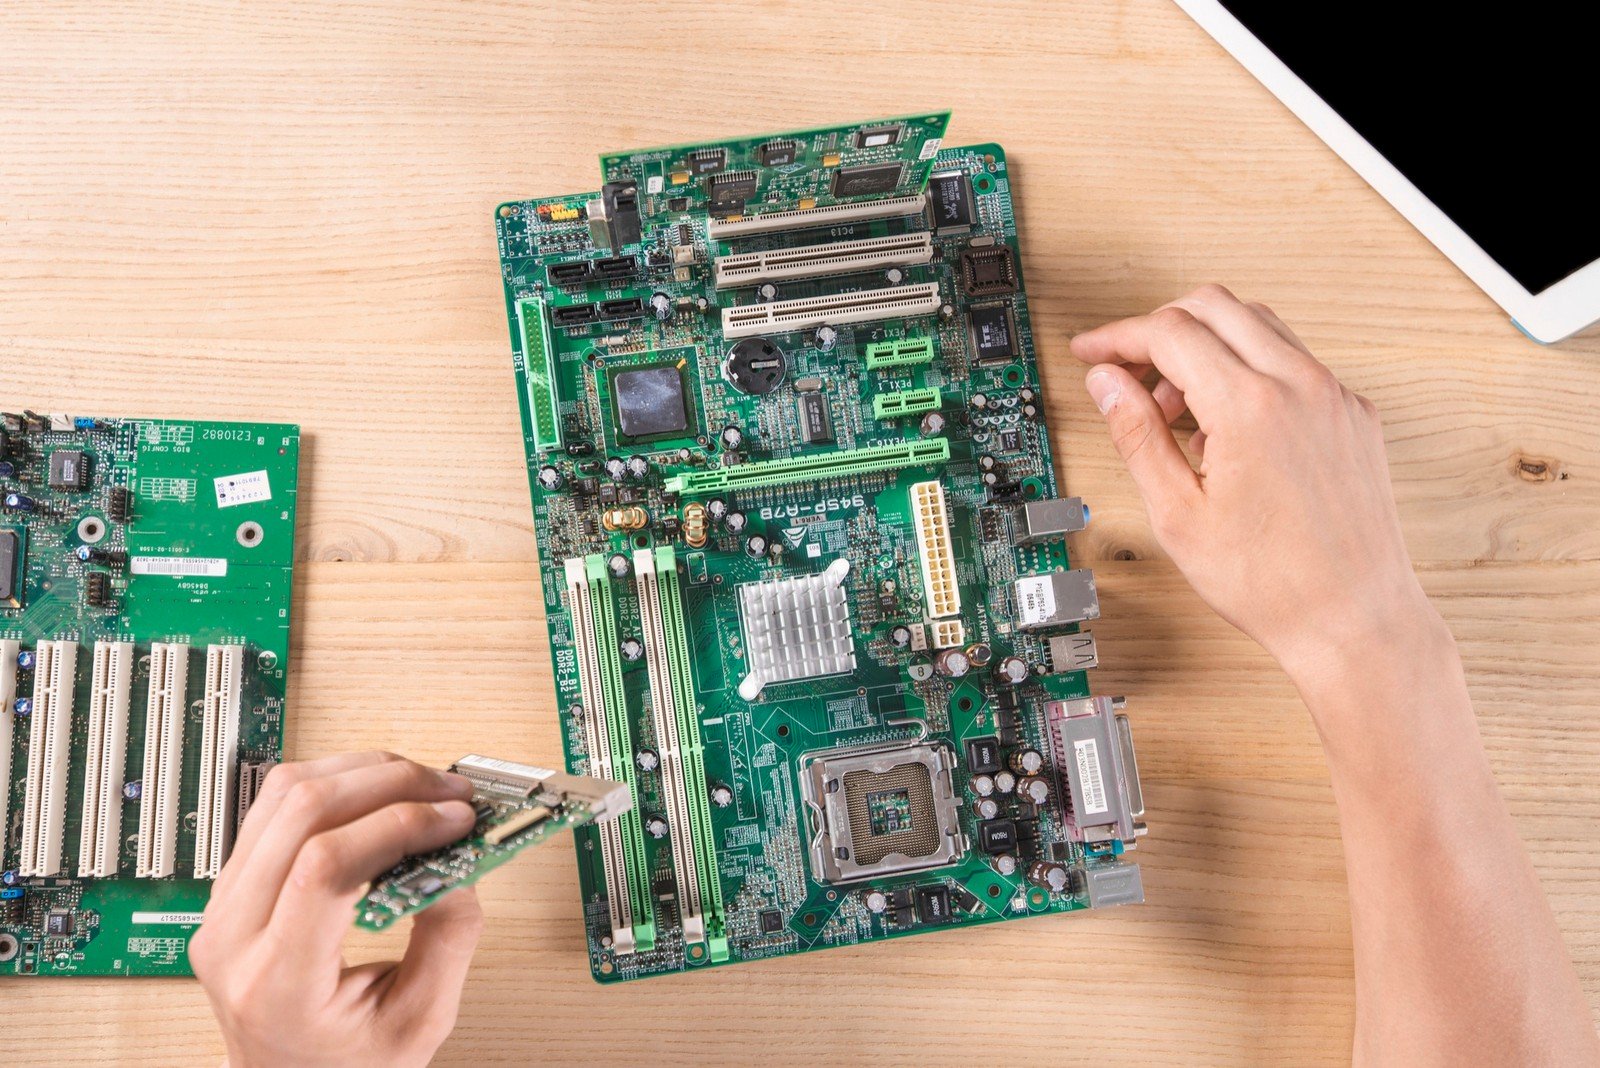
1072,286,1438,684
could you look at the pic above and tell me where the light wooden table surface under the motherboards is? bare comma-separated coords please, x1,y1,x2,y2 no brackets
0,0,1600,1065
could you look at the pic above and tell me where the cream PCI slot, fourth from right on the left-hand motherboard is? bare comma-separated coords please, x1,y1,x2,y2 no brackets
16,641,78,878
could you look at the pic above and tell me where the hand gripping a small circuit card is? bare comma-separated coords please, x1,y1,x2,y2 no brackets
189,753,483,1068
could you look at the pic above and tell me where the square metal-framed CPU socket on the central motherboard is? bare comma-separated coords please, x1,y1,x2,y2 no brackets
800,743,966,883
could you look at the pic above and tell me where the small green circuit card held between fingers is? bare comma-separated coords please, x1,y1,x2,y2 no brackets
355,755,632,931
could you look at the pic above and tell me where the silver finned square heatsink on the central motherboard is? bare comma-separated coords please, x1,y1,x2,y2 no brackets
739,558,856,700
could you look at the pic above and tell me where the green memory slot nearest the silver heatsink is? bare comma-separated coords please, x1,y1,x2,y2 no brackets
656,547,728,961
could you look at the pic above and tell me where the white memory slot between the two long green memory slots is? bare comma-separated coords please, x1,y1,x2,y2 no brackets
634,548,706,945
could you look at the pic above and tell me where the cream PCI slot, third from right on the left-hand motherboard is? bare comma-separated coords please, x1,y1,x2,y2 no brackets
78,641,133,879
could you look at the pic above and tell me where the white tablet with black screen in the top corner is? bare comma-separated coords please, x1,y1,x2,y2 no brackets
1176,0,1600,342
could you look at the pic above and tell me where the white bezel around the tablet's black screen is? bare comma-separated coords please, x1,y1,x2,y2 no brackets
1174,0,1600,342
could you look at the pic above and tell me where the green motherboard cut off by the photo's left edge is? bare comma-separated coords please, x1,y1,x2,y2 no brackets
0,412,299,977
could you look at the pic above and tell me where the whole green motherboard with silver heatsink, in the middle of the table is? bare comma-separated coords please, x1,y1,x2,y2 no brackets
496,115,1144,982
